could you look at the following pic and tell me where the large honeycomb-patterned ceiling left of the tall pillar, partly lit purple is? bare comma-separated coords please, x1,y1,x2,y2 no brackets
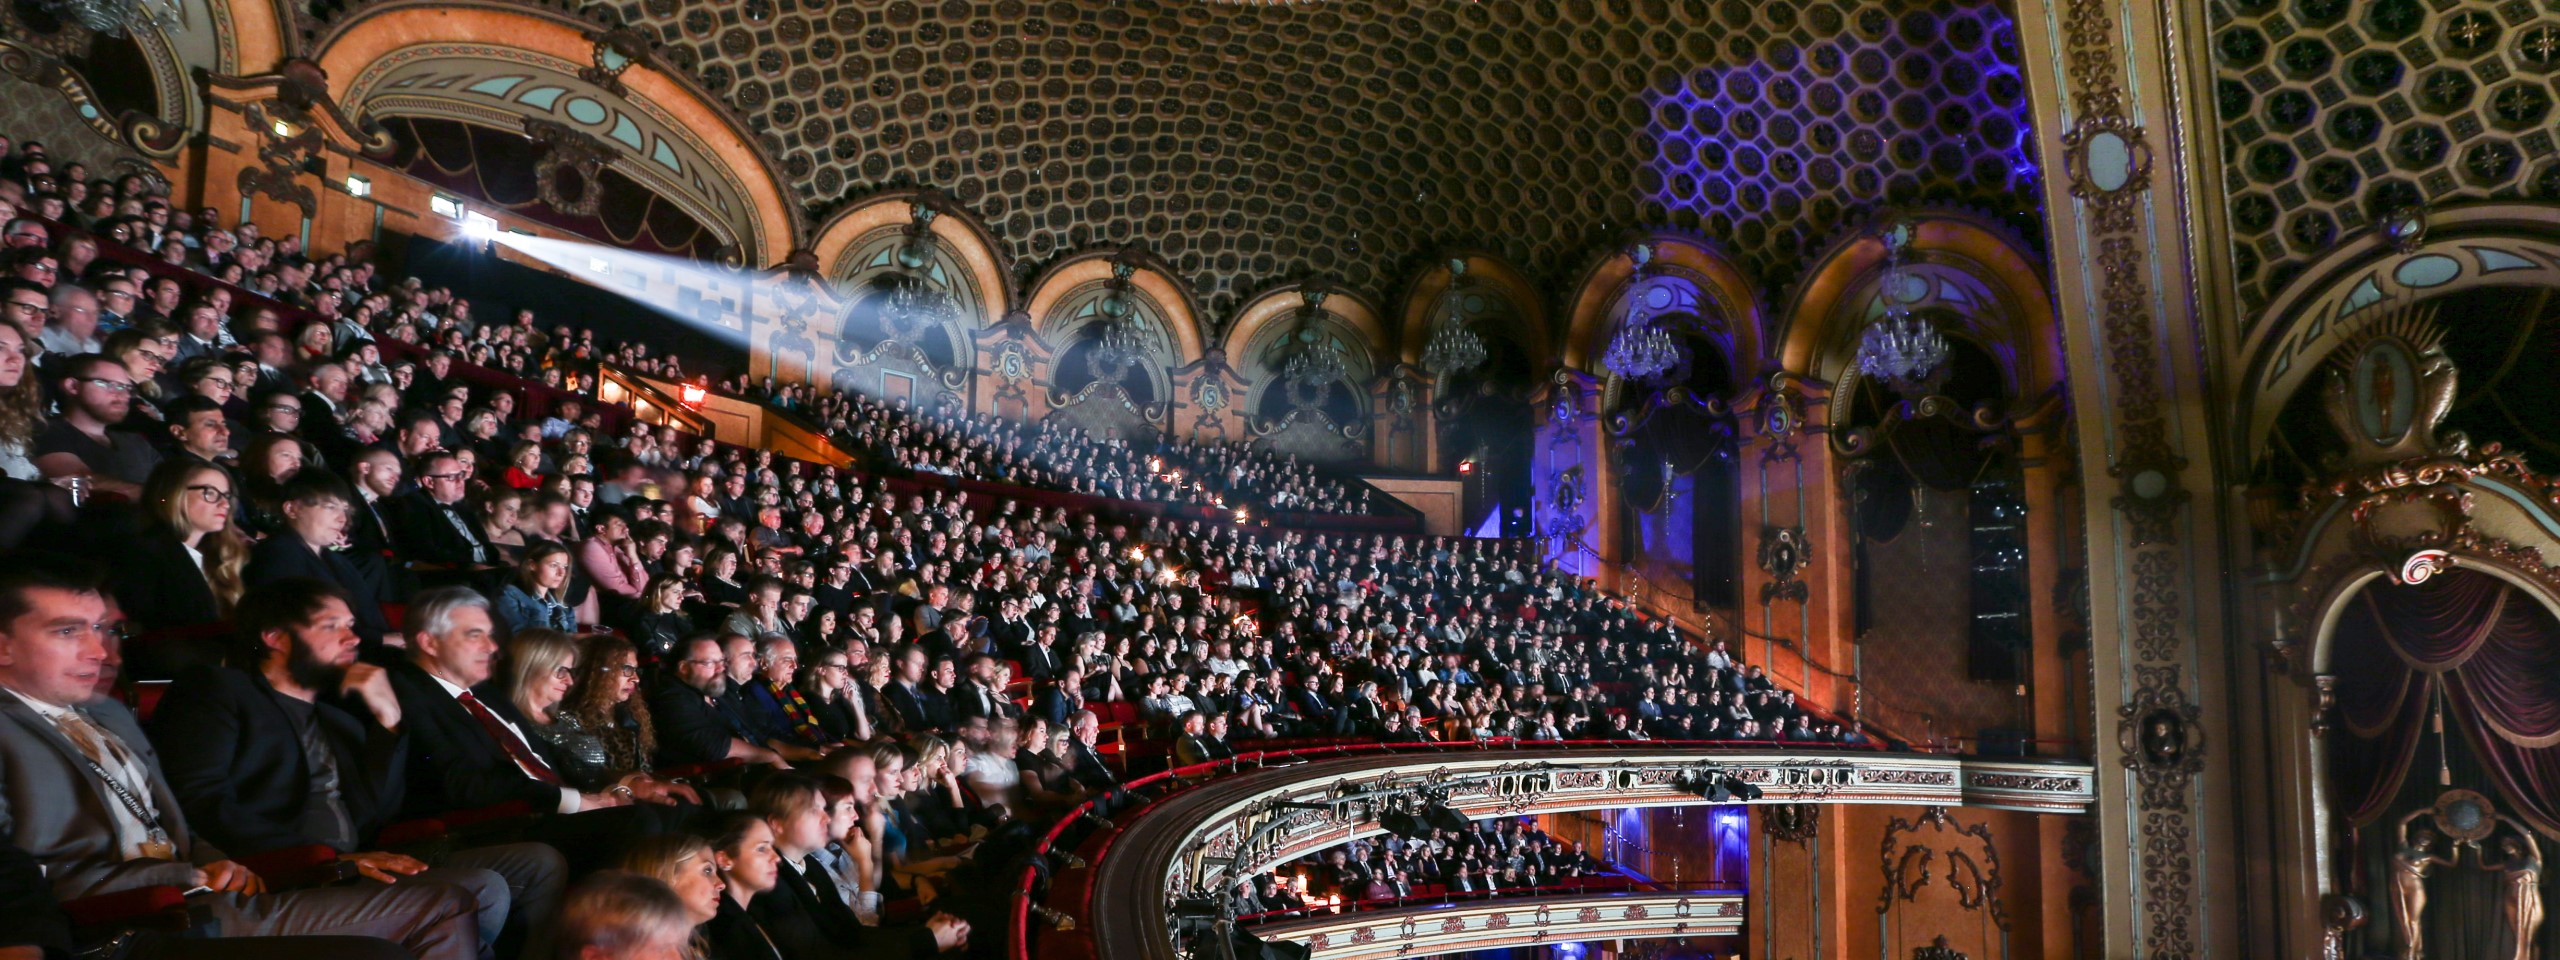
609,0,2043,317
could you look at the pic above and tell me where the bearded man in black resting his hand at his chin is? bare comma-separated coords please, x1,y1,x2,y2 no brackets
151,576,566,945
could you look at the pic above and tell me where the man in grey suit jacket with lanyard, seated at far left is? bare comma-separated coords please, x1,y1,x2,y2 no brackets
0,556,481,960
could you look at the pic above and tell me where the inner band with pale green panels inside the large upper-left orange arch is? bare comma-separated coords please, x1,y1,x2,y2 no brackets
346,44,753,253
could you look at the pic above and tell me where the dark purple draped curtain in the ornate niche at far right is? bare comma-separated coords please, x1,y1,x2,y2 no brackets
2330,571,2560,837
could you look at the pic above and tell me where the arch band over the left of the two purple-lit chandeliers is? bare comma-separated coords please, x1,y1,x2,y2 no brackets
1564,233,1766,381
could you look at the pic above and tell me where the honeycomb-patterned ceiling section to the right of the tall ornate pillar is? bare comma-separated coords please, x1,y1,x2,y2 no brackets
2212,0,2560,325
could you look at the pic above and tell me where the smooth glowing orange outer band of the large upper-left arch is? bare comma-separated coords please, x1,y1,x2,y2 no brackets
312,0,799,264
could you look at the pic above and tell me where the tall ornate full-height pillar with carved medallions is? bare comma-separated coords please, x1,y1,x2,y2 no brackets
2017,0,2240,957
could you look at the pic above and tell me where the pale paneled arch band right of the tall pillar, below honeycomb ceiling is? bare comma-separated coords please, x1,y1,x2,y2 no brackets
2232,200,2560,463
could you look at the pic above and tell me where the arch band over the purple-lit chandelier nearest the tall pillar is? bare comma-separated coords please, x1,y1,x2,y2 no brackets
1777,210,2063,399
